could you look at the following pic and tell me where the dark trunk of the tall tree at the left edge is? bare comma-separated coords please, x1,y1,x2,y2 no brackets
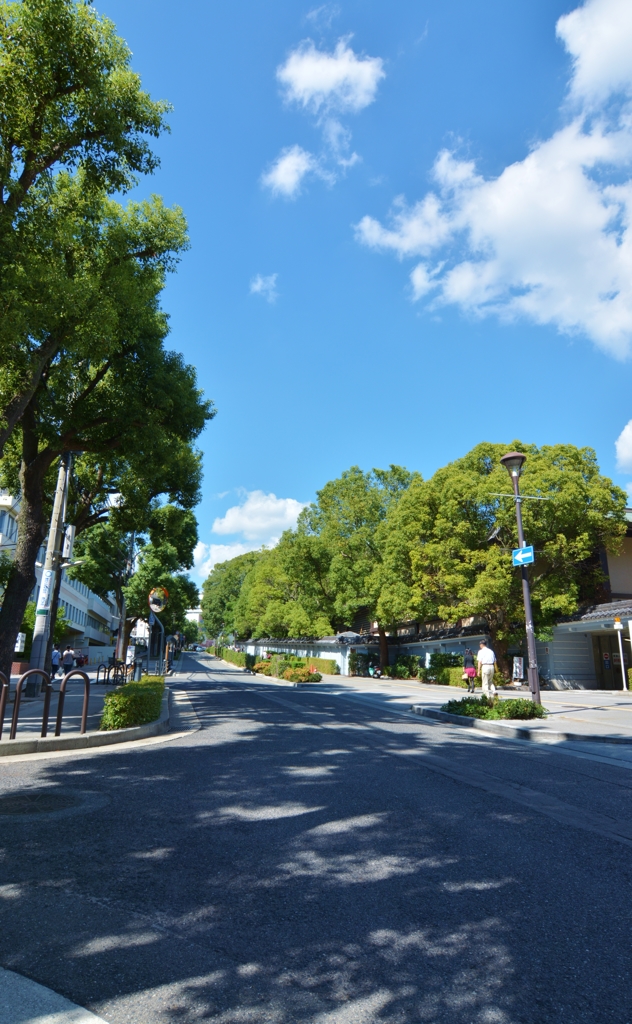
0,411,54,678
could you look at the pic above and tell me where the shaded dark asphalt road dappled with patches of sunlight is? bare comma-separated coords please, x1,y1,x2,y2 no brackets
0,659,632,1024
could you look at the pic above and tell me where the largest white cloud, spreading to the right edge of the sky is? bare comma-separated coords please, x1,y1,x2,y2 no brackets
356,0,632,358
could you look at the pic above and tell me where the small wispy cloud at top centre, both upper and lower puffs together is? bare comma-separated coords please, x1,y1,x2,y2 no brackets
261,37,385,199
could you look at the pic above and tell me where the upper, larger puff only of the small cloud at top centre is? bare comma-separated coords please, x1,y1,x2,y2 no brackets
277,39,384,114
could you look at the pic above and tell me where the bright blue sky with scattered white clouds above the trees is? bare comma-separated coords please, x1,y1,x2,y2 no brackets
96,0,632,579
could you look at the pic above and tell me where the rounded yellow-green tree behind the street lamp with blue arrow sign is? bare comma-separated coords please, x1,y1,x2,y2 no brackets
374,441,626,672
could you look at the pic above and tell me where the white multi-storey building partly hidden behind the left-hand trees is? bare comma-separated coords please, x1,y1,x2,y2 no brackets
0,490,119,660
